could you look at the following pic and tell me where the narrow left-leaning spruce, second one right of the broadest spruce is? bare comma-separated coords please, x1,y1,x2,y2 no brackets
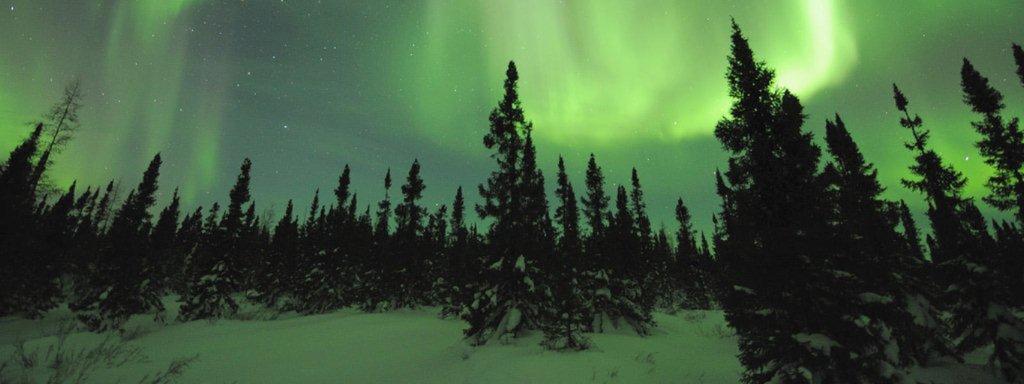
893,85,1024,382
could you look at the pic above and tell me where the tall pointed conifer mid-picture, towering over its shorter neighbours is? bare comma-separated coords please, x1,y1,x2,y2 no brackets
464,61,550,345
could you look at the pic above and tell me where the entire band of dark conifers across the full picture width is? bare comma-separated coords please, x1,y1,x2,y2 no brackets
0,25,1024,383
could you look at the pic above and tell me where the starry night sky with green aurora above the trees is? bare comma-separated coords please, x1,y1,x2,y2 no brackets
0,0,1024,233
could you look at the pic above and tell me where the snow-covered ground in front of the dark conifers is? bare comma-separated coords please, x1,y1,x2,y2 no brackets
0,300,1001,384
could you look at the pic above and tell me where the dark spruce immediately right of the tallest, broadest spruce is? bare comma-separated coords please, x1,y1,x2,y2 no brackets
824,115,951,365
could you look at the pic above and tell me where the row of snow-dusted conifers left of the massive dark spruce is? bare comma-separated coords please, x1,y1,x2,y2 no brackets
0,67,714,349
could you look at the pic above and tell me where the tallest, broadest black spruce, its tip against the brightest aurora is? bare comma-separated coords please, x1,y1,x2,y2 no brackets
715,23,899,383
